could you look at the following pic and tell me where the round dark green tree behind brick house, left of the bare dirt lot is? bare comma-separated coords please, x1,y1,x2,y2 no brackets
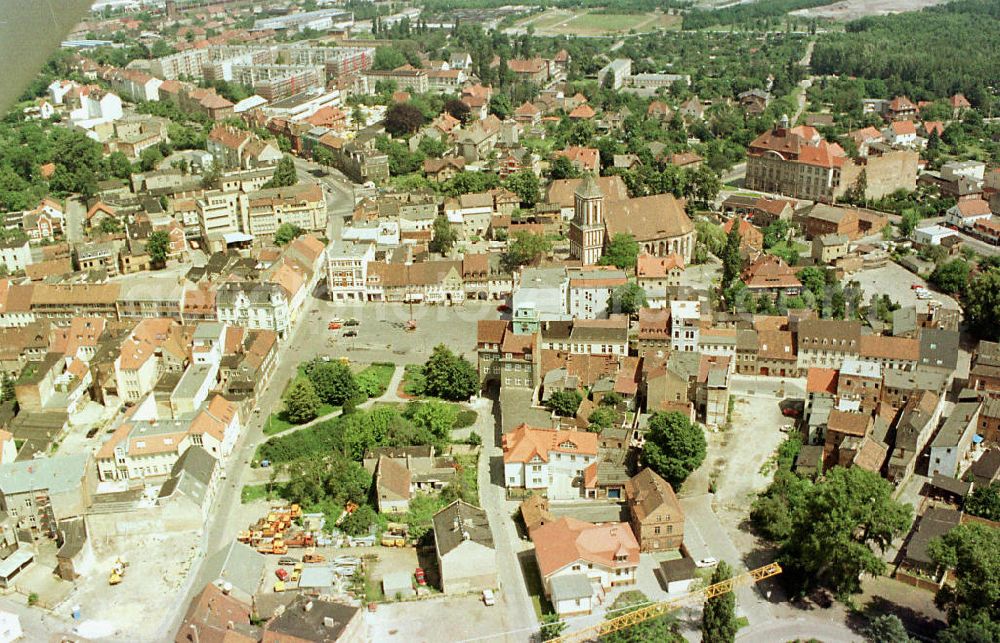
642,412,707,489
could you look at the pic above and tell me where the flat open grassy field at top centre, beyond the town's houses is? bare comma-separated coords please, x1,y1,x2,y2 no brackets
514,9,681,36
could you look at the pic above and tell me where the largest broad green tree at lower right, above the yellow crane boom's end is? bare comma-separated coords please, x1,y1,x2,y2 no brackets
780,467,913,596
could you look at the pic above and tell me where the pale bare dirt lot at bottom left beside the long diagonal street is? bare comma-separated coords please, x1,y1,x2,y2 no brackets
58,533,198,641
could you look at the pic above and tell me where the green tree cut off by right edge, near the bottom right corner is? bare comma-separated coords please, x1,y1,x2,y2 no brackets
927,523,1000,622
